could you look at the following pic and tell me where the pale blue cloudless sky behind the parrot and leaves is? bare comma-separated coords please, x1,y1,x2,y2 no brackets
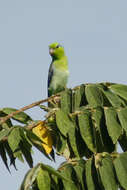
0,0,127,190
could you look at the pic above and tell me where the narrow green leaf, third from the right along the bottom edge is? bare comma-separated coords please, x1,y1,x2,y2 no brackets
85,159,96,190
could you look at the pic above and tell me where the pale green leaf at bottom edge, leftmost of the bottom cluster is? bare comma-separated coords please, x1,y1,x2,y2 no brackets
20,164,40,190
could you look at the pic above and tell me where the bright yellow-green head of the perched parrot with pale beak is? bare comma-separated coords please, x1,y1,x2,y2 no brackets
49,42,65,59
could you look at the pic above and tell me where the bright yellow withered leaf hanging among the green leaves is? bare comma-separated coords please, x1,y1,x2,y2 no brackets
32,121,53,154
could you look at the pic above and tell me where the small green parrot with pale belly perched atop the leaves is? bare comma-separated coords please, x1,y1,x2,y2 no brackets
48,43,69,97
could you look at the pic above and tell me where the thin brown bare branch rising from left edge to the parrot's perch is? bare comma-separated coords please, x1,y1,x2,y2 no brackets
0,94,59,125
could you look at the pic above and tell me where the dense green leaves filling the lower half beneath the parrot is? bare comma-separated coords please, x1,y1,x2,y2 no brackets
0,83,127,190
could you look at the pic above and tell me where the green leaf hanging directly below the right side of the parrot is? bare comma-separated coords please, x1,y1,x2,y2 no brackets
60,89,72,113
